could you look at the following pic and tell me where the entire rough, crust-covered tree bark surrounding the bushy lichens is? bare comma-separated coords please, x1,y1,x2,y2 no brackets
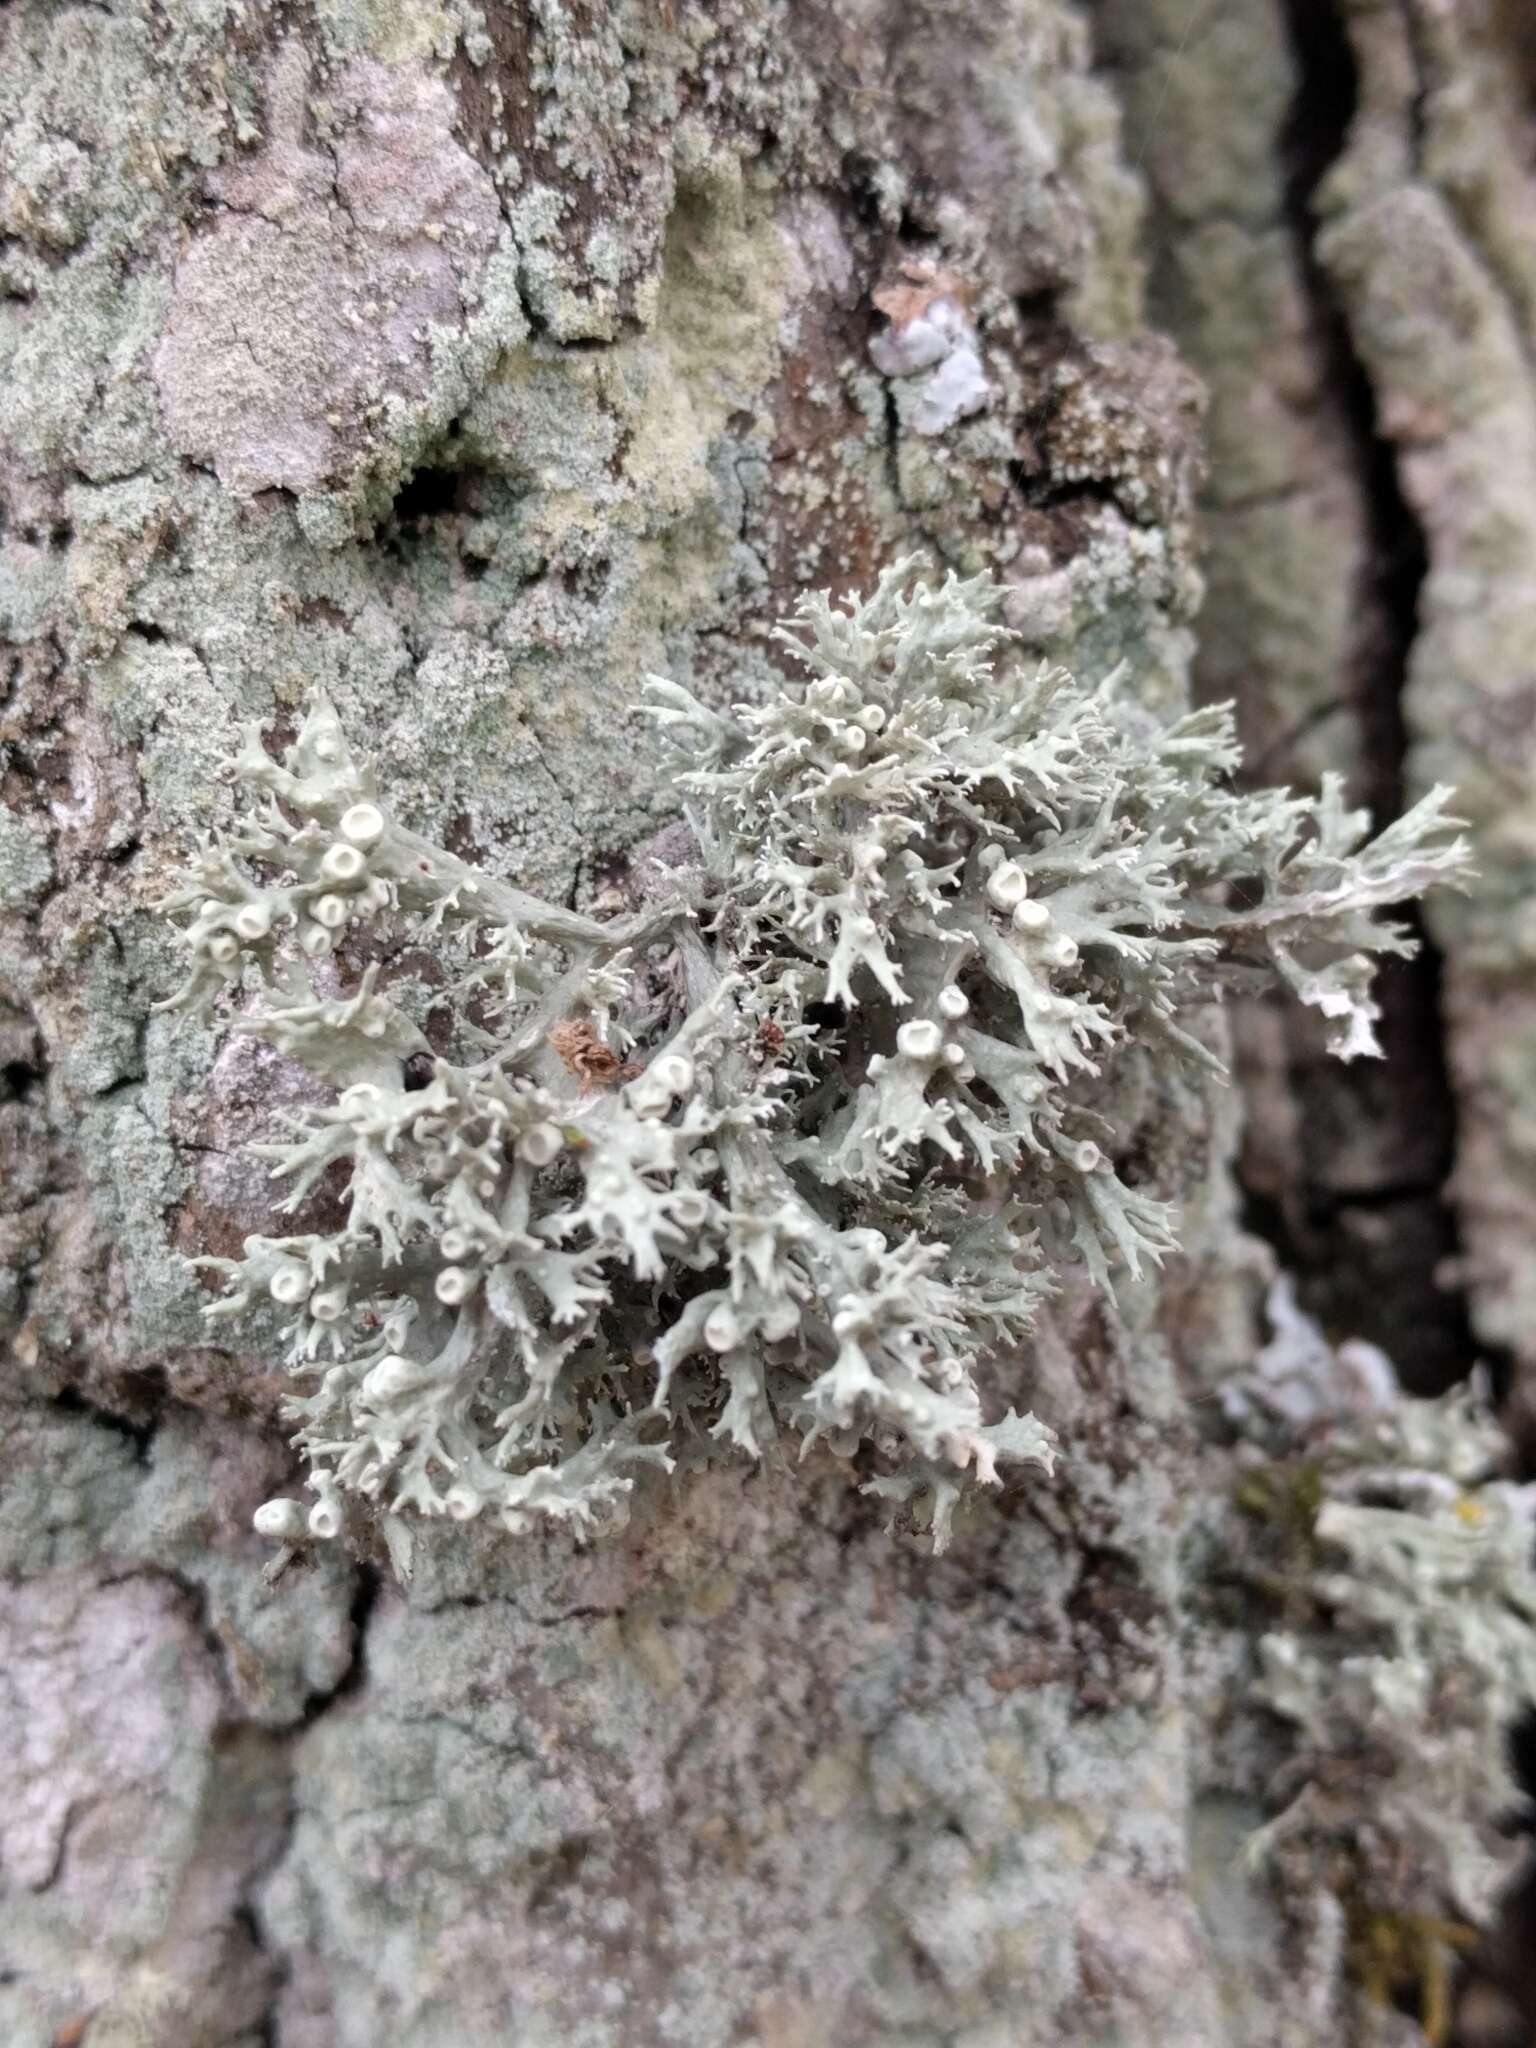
0,0,1536,2048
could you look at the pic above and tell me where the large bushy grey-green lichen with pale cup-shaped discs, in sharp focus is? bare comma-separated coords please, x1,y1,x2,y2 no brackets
159,563,1464,1563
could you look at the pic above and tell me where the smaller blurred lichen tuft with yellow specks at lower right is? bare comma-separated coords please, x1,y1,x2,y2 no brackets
1225,1282,1536,2040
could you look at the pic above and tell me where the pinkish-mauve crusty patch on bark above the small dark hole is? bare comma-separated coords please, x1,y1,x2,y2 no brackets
154,45,500,496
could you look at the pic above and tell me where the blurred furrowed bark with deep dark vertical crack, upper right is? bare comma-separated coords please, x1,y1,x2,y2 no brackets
1094,0,1536,1407
